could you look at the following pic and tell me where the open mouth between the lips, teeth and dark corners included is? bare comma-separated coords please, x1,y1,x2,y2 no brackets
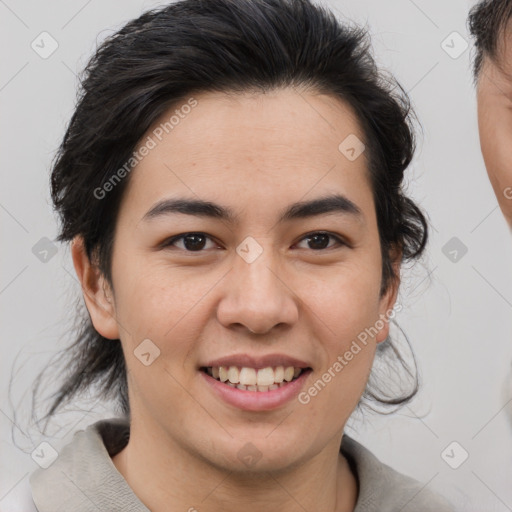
200,366,311,393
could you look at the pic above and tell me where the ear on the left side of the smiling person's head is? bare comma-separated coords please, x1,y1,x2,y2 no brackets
71,236,119,340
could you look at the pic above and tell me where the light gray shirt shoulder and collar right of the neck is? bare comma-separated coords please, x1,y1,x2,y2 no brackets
340,434,454,512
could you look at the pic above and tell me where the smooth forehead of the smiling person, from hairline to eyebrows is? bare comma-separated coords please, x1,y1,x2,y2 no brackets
119,89,371,222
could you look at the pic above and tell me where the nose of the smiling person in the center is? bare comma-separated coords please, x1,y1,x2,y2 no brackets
217,249,299,334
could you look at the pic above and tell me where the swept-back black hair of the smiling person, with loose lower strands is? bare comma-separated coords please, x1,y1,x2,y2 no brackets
30,0,428,428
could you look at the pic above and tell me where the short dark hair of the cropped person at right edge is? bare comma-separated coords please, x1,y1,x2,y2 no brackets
468,0,512,80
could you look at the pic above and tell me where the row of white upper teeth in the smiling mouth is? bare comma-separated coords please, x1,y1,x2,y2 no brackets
207,366,302,386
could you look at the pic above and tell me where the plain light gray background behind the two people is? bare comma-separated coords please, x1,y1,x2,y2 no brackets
0,0,512,512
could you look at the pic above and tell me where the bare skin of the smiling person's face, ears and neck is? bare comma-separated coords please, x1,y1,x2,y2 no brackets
72,89,398,512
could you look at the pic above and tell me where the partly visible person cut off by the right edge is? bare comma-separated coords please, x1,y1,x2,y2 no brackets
468,0,512,230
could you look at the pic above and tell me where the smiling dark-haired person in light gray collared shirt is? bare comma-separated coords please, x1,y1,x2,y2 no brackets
12,0,452,512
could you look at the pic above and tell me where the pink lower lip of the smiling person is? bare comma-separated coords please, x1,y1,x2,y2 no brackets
199,370,311,411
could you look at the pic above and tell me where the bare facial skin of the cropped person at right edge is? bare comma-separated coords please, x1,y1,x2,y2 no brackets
477,36,512,230
